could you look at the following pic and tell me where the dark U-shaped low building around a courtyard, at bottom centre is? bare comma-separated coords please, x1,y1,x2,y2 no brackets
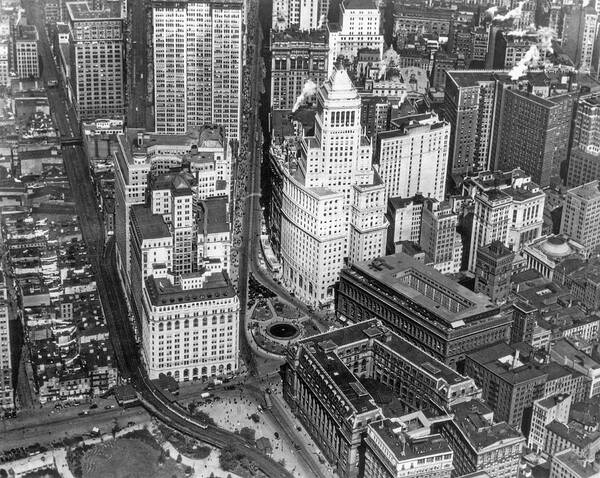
283,320,479,477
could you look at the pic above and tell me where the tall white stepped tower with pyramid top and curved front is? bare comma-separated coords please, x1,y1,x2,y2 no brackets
272,70,387,304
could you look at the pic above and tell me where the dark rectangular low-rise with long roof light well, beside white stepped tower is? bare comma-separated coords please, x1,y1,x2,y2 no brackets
336,253,512,367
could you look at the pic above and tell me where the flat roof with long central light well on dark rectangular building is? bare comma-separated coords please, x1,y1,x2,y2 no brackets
348,252,499,328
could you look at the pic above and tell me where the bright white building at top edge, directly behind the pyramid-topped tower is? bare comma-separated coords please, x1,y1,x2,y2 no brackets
327,0,384,74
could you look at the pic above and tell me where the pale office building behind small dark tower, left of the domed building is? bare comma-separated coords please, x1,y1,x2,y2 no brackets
464,169,546,271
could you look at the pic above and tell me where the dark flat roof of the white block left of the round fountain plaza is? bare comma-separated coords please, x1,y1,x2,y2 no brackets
146,271,236,307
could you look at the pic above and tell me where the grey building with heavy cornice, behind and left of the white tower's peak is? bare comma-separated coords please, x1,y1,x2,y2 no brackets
271,30,329,110
